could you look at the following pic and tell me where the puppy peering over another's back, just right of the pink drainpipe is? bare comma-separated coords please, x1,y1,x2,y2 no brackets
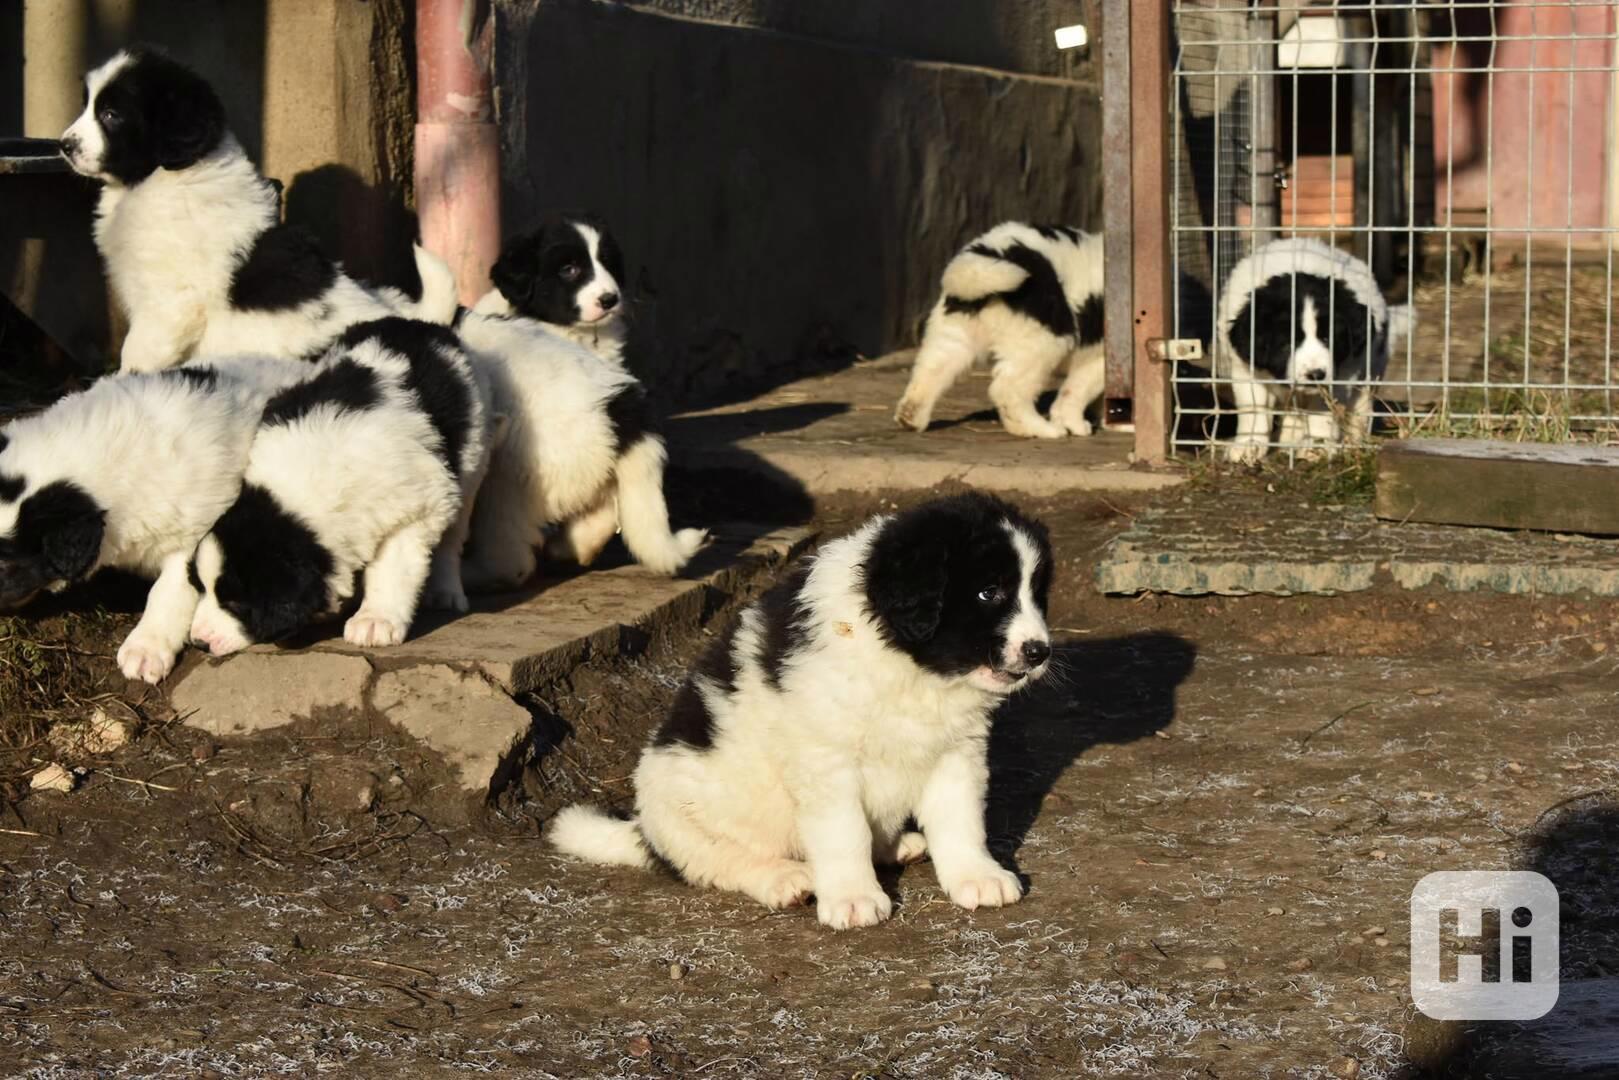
473,212,630,363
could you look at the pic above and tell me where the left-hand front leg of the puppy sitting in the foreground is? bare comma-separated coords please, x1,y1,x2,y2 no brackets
795,764,894,929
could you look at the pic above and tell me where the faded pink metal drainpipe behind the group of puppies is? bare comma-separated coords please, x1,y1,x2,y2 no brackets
416,0,500,304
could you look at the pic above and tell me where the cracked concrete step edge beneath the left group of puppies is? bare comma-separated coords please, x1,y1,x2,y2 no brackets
172,525,813,801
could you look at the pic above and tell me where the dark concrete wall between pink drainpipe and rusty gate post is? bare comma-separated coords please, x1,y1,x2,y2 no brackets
497,0,1101,400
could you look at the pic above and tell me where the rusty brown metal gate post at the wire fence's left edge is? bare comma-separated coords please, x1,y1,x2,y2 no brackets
1133,0,1174,465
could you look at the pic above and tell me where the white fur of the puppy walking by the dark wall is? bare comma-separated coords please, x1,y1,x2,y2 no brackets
894,222,1106,439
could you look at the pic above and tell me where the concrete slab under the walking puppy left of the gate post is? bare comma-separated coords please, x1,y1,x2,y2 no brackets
667,359,1185,495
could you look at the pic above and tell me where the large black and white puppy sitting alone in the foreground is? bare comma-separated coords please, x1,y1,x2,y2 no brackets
550,494,1052,929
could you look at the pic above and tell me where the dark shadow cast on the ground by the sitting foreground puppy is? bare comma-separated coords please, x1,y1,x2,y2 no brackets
988,631,1198,868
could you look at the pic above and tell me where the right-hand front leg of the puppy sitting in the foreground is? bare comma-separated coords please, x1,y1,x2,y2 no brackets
916,740,1023,910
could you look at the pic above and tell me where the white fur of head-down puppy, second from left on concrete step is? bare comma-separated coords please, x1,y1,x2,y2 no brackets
191,333,491,656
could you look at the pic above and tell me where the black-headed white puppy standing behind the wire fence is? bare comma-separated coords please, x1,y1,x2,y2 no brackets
1216,238,1412,461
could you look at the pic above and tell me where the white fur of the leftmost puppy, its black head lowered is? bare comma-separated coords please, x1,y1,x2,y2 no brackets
0,359,293,683
